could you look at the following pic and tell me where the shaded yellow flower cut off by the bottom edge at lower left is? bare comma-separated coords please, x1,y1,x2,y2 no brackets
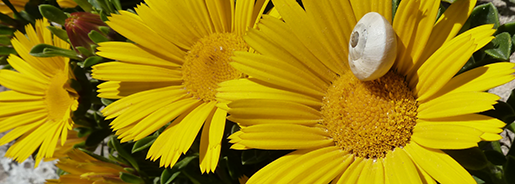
46,149,127,184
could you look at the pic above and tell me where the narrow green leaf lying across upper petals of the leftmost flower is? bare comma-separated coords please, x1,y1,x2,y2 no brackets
30,44,80,60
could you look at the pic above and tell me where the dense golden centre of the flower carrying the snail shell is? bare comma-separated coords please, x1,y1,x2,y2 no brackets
322,71,418,158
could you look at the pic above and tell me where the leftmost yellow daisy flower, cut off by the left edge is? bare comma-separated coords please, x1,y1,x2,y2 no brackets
0,19,78,166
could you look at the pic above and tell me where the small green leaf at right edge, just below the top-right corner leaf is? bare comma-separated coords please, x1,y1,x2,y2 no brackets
485,32,512,61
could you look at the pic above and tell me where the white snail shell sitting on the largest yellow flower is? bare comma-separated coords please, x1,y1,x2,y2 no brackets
349,12,397,81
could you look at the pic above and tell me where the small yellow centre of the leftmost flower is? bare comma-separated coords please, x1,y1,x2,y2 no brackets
45,72,77,122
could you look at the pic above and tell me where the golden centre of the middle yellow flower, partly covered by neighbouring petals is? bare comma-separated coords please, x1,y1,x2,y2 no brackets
182,33,248,102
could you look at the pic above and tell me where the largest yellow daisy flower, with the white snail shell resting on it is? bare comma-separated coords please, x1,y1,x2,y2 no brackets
221,0,515,184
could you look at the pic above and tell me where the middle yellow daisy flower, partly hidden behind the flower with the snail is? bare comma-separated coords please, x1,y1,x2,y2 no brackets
92,0,268,172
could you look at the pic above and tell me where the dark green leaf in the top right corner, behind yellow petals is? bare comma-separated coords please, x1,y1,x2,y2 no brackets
460,2,500,33
